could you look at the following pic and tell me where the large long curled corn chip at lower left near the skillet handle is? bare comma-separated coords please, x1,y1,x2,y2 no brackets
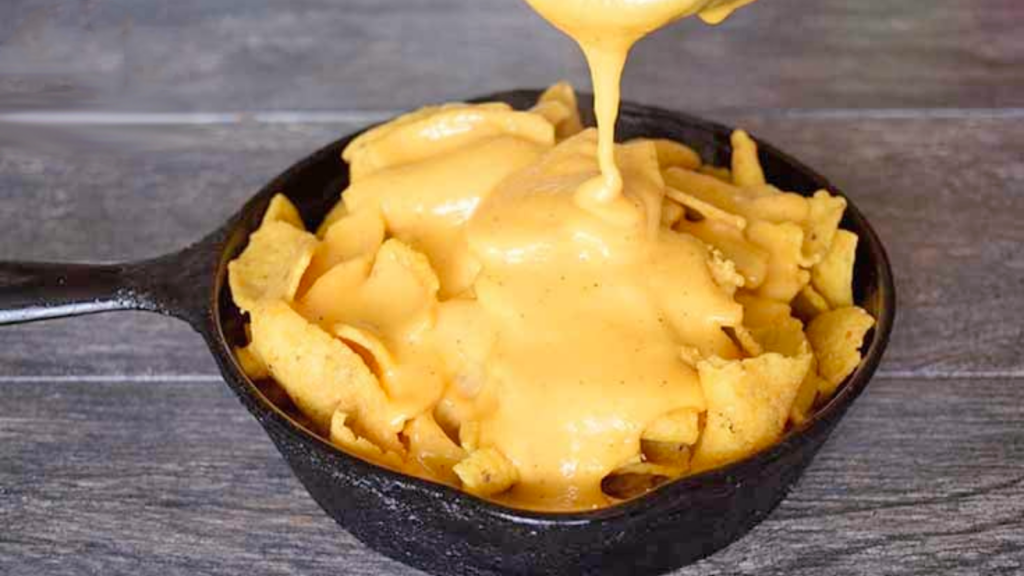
252,300,401,452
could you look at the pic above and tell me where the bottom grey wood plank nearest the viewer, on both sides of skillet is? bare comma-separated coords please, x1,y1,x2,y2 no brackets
0,379,1024,576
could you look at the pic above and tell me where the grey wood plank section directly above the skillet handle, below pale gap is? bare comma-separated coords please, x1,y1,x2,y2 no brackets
0,124,356,260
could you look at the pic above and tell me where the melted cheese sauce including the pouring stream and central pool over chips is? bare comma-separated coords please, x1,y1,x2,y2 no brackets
305,0,761,509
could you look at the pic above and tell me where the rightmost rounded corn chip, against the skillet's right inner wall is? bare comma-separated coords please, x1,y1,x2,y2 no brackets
807,306,874,397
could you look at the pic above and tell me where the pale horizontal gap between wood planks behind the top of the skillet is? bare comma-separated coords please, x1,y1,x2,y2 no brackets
6,108,1024,126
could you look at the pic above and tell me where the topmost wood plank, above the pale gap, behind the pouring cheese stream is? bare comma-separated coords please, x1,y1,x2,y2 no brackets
0,0,1024,111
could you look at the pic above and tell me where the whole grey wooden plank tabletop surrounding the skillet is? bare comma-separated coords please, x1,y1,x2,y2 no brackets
0,0,1024,576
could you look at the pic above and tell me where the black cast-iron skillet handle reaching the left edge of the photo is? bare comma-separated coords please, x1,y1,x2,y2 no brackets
0,239,216,331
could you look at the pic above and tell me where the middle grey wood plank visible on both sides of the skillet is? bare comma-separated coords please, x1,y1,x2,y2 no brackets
0,115,1024,378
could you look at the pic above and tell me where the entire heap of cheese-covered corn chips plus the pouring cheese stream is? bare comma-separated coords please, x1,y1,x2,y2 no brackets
229,0,869,510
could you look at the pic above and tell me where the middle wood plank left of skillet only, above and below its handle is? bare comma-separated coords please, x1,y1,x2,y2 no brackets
0,120,353,378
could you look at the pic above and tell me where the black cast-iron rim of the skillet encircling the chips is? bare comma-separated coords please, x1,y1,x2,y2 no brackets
203,89,896,520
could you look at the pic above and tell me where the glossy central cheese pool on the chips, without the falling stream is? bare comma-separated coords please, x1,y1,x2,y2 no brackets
459,132,741,508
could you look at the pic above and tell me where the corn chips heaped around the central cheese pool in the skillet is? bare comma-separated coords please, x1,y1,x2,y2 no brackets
229,84,874,504
